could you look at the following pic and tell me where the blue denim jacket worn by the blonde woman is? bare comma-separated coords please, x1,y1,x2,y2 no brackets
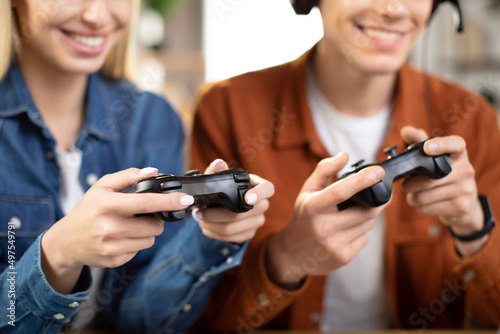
0,64,246,333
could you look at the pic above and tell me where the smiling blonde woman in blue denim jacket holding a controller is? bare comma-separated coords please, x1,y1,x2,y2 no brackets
0,0,273,333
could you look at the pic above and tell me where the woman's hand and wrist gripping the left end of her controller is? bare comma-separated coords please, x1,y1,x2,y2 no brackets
42,168,194,293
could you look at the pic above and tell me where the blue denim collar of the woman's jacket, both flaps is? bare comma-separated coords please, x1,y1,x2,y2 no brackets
0,64,119,144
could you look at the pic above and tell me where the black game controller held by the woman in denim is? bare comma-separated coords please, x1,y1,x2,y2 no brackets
128,168,253,222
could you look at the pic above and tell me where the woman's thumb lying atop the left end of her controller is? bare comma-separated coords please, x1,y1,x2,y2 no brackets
94,167,158,192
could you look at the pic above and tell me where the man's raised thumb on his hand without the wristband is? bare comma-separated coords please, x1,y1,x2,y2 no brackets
300,152,349,192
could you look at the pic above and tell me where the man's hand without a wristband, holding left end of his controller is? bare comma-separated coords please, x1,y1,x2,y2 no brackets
266,153,385,287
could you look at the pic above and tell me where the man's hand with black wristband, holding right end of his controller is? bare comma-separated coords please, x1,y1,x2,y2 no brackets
401,126,487,256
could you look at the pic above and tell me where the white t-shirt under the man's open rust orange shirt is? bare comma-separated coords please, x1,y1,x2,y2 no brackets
307,71,391,331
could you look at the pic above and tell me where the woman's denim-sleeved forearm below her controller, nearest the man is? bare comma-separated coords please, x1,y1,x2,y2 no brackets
99,219,246,333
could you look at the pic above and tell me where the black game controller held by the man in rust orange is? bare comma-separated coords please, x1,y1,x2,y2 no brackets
337,139,451,210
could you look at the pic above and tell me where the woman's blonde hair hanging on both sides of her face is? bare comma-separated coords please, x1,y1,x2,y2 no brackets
0,0,141,81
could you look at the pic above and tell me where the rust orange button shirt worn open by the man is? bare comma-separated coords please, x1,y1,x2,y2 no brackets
191,51,500,332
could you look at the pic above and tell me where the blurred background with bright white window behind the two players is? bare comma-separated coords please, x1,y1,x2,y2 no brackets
138,0,500,130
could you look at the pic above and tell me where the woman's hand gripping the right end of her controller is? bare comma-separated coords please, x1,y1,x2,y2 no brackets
193,159,274,243
